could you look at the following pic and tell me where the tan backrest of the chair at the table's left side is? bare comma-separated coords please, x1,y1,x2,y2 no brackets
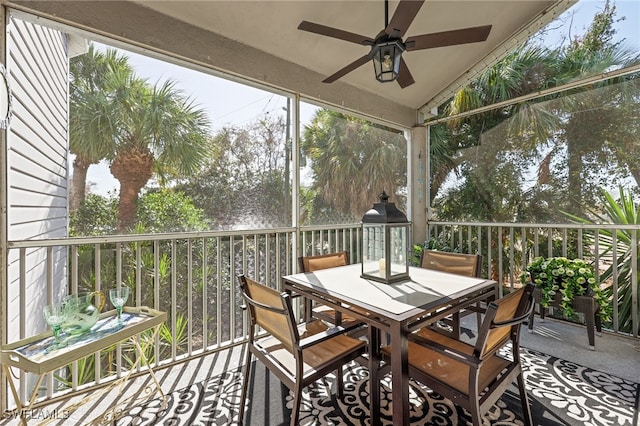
240,276,298,351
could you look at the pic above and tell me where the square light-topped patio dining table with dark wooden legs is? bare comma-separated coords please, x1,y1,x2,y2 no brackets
283,264,498,425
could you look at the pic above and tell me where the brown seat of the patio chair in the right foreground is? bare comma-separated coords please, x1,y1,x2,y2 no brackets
382,328,510,395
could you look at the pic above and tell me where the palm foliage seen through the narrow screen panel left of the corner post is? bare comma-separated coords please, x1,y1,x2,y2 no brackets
301,109,407,220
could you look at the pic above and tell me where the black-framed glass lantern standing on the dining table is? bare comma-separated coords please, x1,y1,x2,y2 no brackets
362,191,411,284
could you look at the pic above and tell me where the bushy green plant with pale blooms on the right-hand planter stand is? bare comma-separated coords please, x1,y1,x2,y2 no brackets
520,257,611,321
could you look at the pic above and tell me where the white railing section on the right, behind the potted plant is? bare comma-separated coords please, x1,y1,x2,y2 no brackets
427,221,640,337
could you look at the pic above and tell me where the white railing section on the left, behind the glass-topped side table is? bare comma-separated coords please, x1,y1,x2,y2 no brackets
0,224,360,410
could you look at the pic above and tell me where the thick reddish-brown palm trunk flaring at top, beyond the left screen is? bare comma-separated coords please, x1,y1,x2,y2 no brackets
110,149,154,234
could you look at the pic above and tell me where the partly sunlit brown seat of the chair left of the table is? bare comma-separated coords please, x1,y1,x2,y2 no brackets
255,321,366,377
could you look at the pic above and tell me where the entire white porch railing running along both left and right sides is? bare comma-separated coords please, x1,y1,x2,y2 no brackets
0,222,640,410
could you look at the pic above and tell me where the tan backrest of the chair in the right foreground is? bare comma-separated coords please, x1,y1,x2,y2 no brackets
476,285,533,358
